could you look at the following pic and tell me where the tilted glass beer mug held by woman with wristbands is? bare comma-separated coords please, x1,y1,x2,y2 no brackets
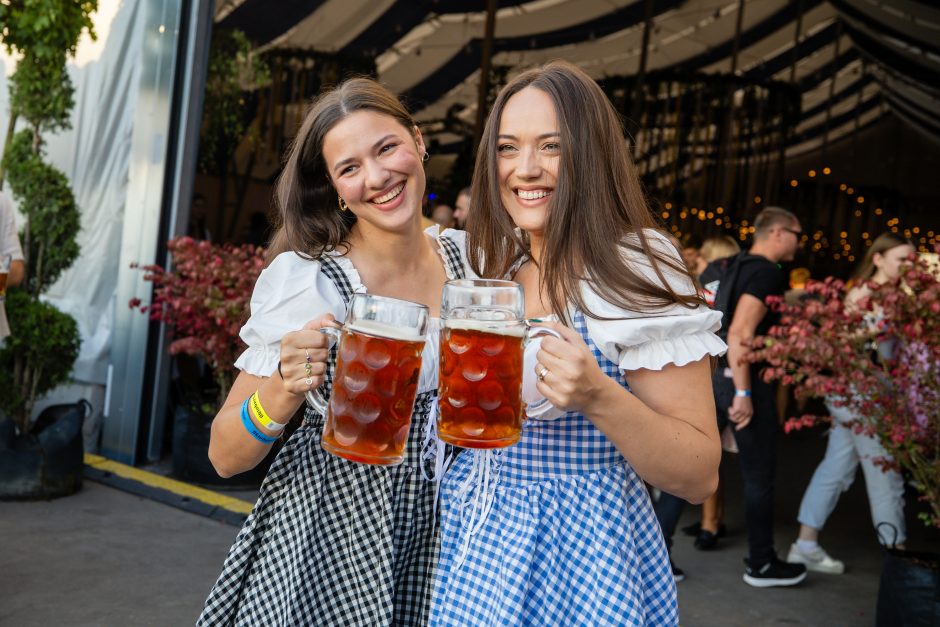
307,294,428,466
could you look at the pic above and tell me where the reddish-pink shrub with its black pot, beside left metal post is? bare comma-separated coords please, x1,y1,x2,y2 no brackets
129,237,273,485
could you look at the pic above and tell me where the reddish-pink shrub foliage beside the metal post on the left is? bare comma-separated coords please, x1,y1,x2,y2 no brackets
129,237,264,405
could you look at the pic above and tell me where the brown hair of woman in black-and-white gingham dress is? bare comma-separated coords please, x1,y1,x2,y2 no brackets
268,77,416,262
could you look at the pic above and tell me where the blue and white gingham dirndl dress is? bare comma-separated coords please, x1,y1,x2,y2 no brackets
430,312,678,627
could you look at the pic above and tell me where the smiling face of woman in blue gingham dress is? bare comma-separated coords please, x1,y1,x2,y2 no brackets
496,87,561,242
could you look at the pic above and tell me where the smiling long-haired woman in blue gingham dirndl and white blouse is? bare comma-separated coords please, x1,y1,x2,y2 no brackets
430,62,726,627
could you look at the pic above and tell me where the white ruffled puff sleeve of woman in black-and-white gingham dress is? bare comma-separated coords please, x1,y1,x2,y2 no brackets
235,252,350,377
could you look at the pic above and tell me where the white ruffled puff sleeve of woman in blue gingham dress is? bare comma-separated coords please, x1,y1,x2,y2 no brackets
582,229,728,371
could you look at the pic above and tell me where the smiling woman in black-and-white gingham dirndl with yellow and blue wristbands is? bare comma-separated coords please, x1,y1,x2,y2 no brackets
199,79,474,625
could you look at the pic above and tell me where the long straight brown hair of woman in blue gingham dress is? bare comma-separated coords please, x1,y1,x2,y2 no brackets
467,61,703,320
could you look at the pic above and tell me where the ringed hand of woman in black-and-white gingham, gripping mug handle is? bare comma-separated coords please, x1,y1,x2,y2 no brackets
278,313,340,395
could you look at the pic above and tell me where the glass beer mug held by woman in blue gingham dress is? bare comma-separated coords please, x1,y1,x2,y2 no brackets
437,279,561,448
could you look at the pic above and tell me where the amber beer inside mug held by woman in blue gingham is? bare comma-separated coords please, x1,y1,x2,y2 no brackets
437,320,525,448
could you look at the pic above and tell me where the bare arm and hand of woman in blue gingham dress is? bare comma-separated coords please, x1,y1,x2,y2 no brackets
536,323,721,503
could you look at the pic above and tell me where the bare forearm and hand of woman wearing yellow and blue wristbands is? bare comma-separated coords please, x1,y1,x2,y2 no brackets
209,314,335,477
